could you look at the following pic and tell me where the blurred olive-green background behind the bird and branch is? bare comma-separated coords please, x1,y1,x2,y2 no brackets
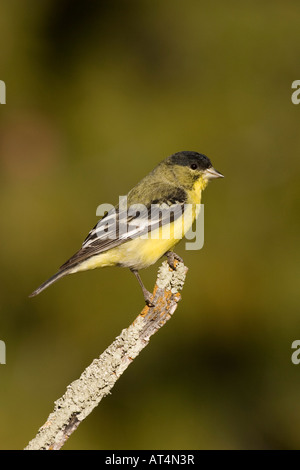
0,0,300,449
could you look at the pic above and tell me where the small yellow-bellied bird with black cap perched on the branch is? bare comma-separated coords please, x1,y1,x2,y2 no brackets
29,151,223,306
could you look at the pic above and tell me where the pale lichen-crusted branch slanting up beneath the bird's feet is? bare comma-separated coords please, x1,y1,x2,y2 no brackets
25,261,187,450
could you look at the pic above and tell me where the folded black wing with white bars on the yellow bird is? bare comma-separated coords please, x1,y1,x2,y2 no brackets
60,187,186,270
